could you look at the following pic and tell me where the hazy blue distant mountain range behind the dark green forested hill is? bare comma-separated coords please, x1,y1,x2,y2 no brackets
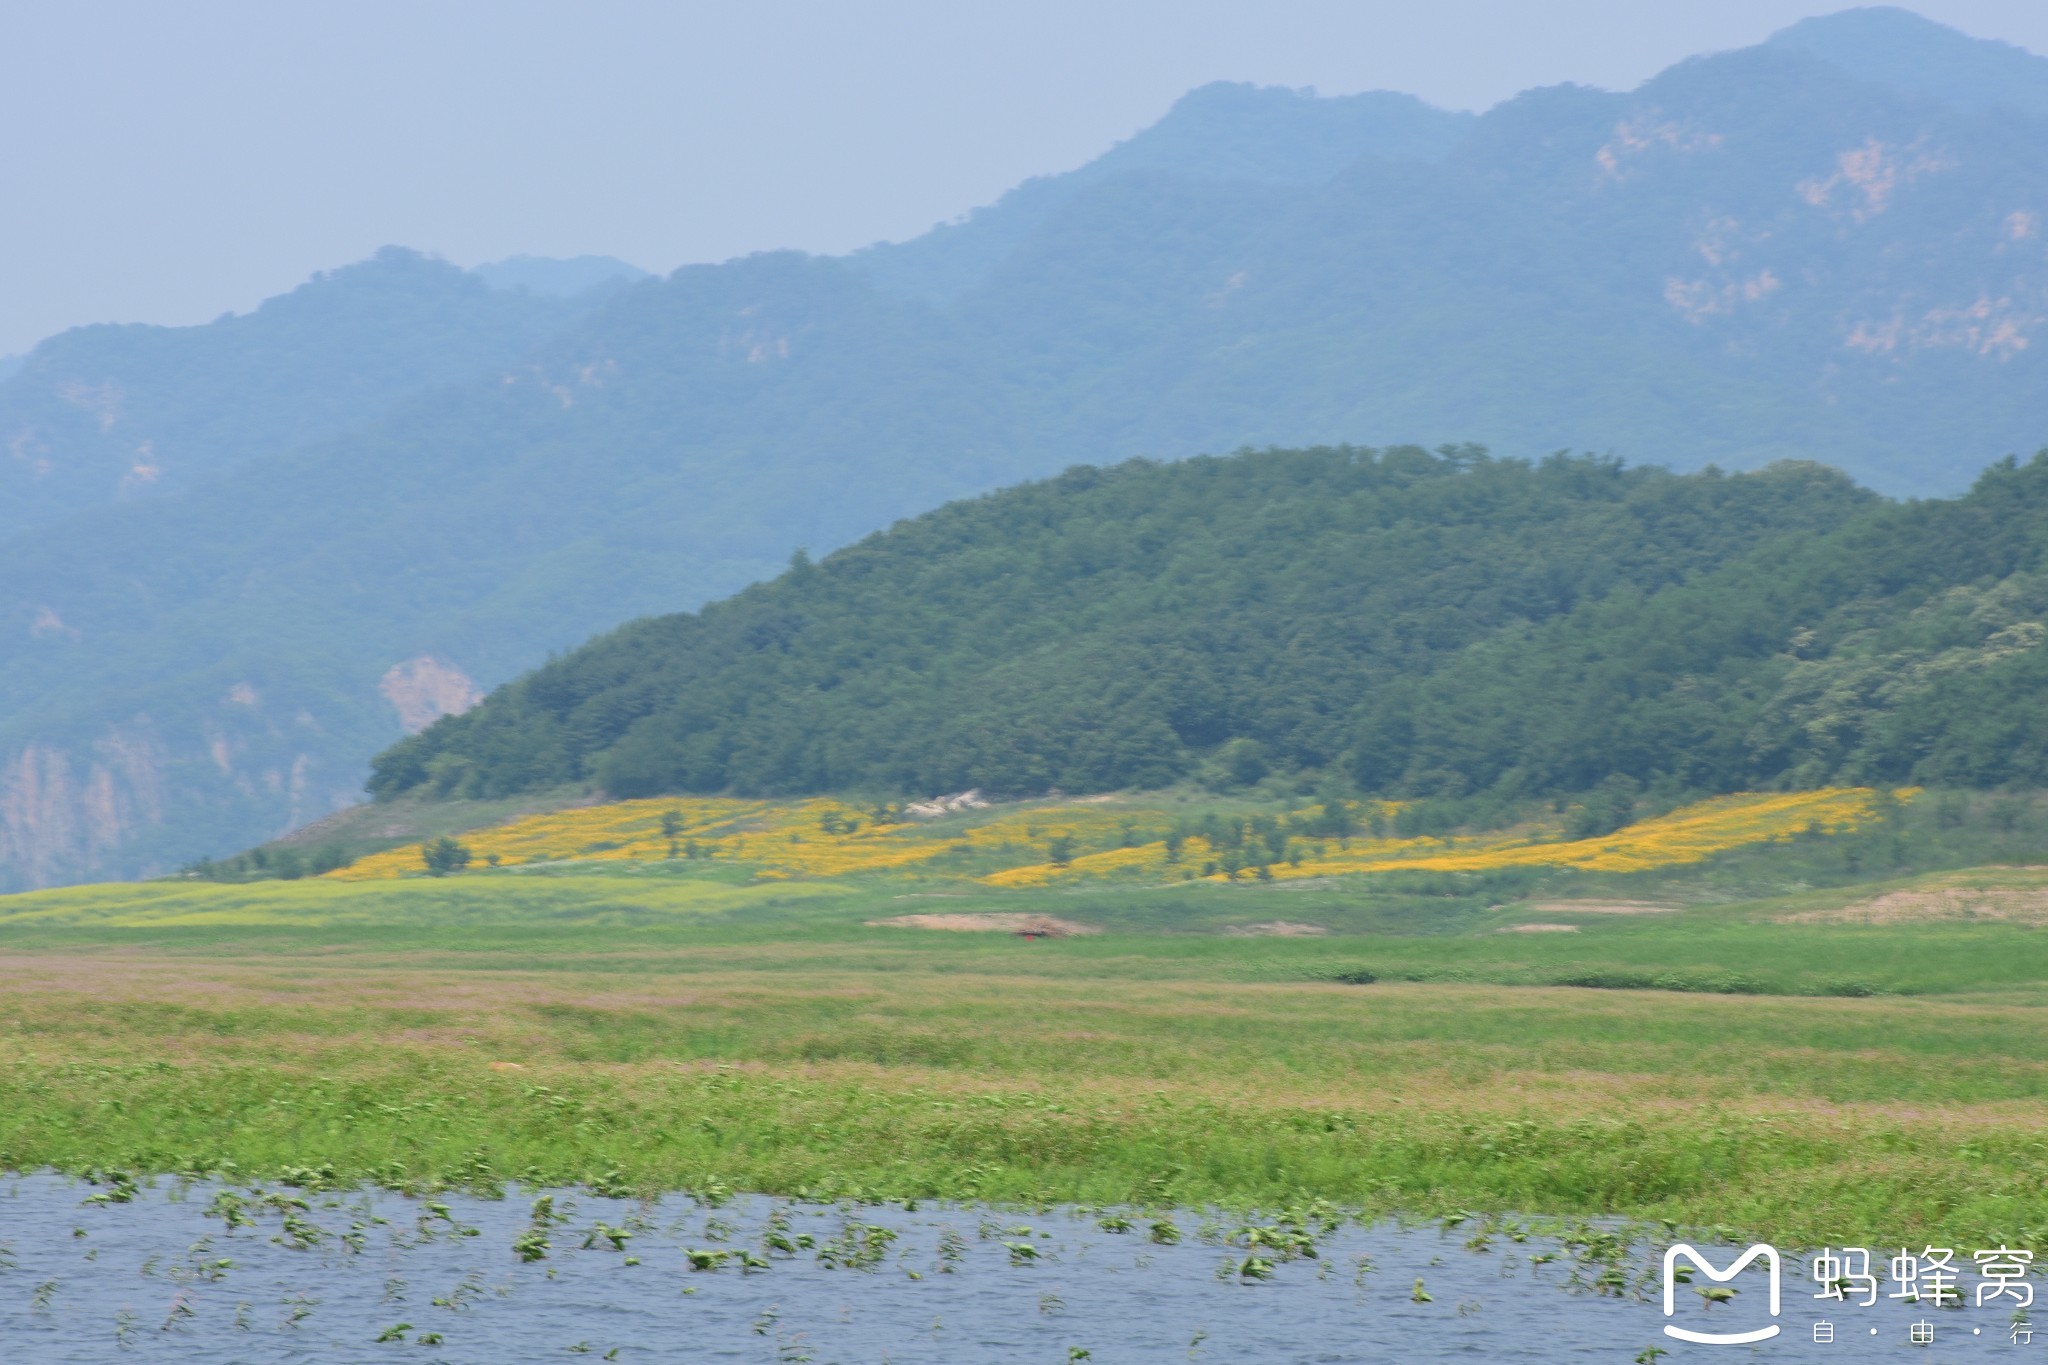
0,10,2048,886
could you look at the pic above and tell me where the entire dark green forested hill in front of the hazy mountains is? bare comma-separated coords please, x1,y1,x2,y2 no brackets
360,448,2048,796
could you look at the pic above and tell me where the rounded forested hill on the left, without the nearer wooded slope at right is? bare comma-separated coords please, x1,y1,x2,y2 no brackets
371,448,1900,796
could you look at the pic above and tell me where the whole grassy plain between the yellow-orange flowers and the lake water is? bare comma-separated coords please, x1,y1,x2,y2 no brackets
0,789,2048,1244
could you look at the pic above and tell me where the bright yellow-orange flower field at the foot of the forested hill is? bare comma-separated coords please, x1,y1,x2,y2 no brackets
328,788,1911,888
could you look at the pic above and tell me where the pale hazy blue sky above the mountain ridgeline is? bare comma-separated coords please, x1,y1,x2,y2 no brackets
0,0,2048,356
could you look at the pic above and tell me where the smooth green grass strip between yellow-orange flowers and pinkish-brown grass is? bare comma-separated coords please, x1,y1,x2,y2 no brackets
12,868,2048,1001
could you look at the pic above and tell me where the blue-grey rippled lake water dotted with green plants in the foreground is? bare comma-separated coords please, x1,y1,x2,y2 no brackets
0,1175,2023,1365
